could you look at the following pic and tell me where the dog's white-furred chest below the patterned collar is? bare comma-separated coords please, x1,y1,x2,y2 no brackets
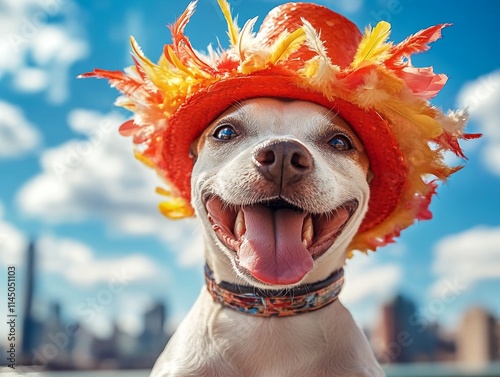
151,290,383,377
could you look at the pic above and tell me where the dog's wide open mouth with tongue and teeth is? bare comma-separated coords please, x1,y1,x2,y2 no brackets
206,196,358,285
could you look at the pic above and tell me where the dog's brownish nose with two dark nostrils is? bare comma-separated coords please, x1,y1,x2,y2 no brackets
253,139,314,187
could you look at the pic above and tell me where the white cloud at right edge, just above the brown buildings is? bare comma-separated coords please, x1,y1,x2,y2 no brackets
432,226,500,295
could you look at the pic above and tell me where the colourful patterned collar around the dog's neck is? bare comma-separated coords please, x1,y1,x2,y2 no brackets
205,265,344,317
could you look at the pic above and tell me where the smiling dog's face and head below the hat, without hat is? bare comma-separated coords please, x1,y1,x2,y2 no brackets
192,98,370,287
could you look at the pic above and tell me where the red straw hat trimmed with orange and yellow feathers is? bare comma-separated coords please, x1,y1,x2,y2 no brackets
81,0,478,251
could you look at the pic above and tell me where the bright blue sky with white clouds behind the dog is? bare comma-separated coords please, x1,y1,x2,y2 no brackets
0,0,500,335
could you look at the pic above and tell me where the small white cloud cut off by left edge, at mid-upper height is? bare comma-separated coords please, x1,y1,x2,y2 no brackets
0,100,40,158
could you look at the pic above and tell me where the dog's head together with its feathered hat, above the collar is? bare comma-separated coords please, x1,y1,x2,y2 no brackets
80,0,472,286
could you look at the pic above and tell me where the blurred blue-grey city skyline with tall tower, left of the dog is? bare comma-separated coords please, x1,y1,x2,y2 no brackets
0,236,170,372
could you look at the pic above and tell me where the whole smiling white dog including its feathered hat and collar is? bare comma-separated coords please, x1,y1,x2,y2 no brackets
79,0,472,377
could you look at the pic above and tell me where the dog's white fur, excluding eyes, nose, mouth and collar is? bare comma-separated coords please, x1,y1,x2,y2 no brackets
151,98,384,377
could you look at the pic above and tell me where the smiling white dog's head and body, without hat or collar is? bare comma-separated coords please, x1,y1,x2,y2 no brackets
151,98,385,377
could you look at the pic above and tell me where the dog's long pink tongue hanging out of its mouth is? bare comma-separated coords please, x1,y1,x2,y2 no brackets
238,206,313,285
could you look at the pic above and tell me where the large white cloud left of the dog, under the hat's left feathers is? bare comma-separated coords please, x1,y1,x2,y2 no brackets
17,109,202,265
